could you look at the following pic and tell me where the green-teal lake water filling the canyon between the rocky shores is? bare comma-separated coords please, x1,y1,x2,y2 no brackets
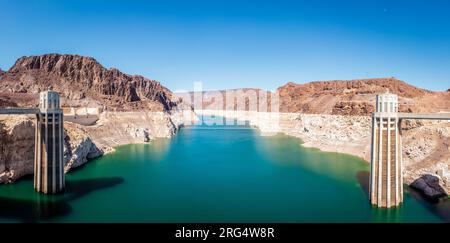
0,117,450,222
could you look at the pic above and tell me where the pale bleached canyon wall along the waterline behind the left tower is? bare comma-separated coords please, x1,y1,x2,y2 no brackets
0,110,196,183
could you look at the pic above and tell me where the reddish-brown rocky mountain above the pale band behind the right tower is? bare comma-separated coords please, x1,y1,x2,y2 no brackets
278,78,450,115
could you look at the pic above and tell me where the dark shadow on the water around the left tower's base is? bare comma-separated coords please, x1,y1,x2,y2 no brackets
0,177,124,222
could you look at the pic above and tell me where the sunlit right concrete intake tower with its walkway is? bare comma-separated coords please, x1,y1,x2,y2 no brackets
369,92,450,208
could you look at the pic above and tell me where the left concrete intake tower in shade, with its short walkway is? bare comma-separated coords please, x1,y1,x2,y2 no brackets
0,90,65,194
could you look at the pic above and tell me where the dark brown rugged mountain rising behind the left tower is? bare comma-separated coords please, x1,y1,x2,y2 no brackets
0,54,177,111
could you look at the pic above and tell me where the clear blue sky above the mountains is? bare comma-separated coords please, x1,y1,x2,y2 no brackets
0,0,450,91
